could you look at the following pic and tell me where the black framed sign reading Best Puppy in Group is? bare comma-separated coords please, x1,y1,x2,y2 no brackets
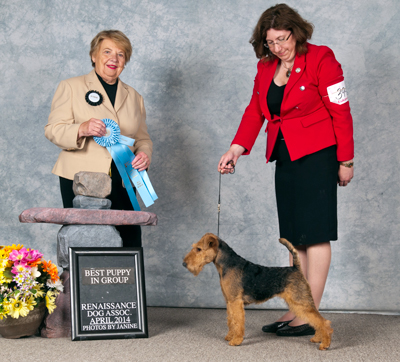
69,248,148,341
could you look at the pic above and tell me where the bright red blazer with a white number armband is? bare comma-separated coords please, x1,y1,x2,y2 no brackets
232,44,354,162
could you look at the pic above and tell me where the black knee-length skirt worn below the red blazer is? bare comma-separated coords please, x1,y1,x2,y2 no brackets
272,138,339,245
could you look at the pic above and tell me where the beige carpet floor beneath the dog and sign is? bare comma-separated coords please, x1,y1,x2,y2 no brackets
0,307,400,362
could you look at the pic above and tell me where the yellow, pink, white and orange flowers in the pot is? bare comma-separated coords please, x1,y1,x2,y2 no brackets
0,244,64,319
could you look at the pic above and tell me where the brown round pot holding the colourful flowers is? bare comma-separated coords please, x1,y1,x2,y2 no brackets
0,303,46,338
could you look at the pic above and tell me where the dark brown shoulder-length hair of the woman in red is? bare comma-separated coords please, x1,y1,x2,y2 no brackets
250,4,314,61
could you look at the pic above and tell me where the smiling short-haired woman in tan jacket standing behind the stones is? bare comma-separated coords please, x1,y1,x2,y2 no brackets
45,30,153,247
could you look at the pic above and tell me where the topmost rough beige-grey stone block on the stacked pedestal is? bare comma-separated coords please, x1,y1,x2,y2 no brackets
72,171,111,199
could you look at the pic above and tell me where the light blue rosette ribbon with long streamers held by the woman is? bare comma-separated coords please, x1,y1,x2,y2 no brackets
93,118,158,211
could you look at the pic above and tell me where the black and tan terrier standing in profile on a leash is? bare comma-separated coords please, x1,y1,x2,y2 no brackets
183,233,333,350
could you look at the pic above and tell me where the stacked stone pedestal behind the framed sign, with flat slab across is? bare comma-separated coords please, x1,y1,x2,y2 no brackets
19,172,157,338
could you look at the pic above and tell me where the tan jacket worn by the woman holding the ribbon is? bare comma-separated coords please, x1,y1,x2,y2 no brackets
45,70,153,180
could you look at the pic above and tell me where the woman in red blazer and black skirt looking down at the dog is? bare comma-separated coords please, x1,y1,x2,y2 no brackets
218,4,354,336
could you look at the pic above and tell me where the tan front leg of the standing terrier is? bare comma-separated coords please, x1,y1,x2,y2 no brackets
225,299,245,346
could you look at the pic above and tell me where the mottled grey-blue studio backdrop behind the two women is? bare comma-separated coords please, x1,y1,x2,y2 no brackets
0,0,400,313
